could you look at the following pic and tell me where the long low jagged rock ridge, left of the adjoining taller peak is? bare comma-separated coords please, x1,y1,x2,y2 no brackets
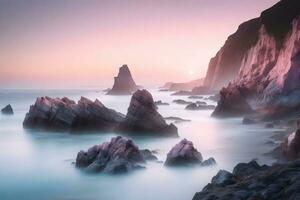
23,97,124,131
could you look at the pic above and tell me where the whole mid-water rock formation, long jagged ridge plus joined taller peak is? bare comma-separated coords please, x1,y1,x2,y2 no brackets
23,90,178,136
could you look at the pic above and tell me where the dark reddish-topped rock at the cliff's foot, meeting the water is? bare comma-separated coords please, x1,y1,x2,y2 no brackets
212,86,253,117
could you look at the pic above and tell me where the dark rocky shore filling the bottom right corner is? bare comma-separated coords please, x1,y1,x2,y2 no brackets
193,160,300,200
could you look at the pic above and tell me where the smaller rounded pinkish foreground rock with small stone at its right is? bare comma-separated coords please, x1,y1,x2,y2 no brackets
165,139,216,166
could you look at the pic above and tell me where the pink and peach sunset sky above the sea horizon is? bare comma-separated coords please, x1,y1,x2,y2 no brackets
0,0,278,88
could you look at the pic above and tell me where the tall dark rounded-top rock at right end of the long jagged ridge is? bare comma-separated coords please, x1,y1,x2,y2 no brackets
116,90,178,136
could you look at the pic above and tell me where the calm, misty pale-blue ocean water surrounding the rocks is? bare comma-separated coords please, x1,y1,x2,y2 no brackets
0,90,273,200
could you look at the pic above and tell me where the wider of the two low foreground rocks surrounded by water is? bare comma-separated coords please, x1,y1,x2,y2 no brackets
76,136,156,174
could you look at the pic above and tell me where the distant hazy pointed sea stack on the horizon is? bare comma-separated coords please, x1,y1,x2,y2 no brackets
107,65,138,95
